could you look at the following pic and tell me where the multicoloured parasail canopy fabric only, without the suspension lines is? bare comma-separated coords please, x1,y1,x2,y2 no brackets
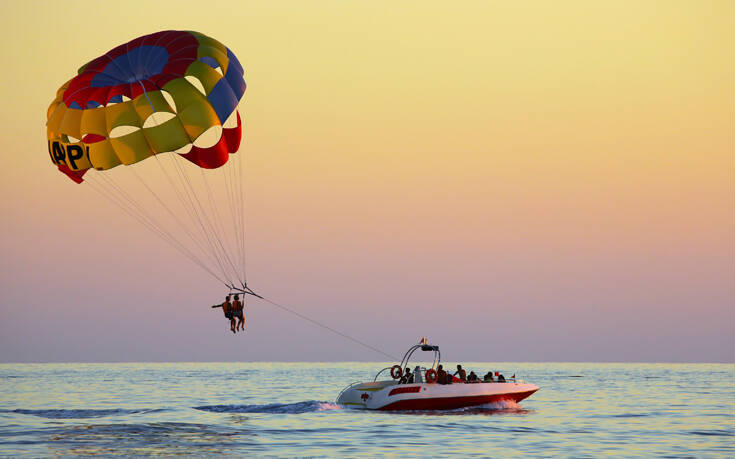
46,30,245,183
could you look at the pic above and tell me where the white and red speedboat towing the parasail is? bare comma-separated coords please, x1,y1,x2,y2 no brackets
337,339,539,410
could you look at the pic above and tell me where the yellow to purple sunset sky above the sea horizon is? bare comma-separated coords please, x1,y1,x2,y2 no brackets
0,1,735,362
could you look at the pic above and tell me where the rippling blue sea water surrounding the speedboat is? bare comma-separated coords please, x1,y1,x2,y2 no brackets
0,362,735,458
